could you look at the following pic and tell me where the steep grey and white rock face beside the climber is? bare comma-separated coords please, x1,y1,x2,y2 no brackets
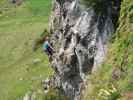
50,0,119,100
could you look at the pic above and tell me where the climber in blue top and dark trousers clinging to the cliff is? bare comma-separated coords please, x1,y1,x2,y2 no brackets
43,37,54,60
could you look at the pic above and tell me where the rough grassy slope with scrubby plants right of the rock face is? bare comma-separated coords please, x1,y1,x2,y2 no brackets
84,0,133,100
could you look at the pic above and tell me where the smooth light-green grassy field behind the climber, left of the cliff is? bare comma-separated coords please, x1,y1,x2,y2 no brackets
0,0,52,100
